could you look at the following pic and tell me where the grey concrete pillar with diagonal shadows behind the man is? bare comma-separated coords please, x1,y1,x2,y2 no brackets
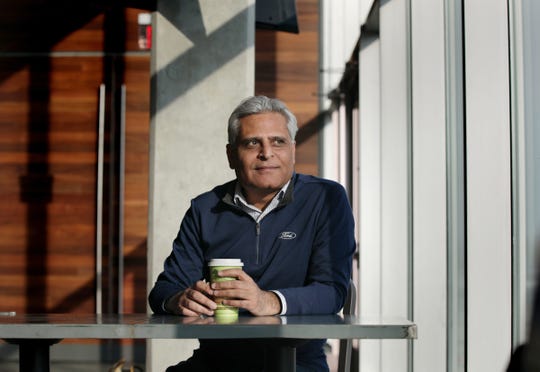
147,0,255,371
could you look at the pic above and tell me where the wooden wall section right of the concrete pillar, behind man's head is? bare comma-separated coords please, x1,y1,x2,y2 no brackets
255,0,320,175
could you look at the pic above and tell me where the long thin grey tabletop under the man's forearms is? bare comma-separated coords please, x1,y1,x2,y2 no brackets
0,314,417,339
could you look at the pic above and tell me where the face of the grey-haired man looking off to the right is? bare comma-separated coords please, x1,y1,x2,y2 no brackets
227,112,295,199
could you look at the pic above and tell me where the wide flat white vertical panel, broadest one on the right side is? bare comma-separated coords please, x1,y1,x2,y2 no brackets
463,0,512,371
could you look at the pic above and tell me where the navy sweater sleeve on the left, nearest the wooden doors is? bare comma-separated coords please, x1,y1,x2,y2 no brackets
148,204,204,314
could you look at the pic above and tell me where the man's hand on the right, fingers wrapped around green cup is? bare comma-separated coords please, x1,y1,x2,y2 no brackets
211,269,281,315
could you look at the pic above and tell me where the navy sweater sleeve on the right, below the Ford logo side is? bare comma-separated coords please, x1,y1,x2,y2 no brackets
279,184,356,315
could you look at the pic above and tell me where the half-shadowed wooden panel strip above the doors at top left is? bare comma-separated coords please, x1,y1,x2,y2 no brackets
0,0,146,53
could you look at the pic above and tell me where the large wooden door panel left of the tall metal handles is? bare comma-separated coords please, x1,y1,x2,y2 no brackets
0,56,102,312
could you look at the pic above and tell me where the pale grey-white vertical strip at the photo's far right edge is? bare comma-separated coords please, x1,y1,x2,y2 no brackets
509,0,540,346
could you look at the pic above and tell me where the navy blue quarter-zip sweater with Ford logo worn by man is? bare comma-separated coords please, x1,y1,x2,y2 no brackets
149,174,355,368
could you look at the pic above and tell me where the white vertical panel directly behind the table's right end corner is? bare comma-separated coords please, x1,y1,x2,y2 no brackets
410,0,448,372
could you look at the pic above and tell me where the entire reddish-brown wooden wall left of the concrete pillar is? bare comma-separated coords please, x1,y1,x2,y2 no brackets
0,0,150,313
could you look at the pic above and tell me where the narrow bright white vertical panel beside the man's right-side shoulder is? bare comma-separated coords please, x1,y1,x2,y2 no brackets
355,30,382,371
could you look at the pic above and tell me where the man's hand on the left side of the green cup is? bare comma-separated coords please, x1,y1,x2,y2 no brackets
165,280,217,316
